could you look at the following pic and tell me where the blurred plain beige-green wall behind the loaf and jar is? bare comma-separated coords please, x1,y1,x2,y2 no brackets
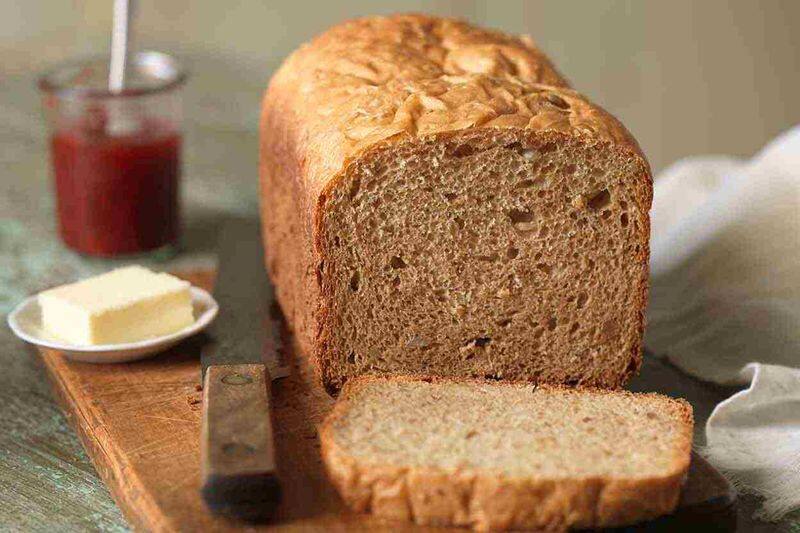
0,0,800,170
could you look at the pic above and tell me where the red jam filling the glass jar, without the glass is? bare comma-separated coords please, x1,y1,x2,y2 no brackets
51,117,181,256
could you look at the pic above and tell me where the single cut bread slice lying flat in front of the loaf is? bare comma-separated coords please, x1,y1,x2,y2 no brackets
321,376,693,530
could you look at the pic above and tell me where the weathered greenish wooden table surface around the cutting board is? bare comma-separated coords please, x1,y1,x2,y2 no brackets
0,57,788,532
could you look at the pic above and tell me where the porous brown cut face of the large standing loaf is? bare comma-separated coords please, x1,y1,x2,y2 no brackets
320,130,649,387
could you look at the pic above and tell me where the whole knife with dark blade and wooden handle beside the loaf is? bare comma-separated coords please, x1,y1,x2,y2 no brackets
200,218,289,522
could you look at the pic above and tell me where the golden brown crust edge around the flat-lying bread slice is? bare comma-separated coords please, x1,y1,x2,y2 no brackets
320,376,694,531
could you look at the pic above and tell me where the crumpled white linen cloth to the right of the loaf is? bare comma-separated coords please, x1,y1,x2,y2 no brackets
645,127,800,519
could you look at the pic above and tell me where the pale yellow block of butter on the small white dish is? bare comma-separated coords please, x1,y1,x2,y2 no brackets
39,266,194,345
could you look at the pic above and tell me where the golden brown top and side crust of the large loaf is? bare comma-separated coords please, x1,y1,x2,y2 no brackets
260,15,650,391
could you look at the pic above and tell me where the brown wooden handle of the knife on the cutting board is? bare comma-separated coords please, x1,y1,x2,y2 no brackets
200,364,281,522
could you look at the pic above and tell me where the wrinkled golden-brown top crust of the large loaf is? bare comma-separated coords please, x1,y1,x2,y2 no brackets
261,14,649,204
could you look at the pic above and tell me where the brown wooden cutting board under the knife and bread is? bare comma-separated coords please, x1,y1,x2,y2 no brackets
41,272,735,531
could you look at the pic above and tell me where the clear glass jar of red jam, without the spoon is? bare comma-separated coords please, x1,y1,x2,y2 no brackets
39,52,186,257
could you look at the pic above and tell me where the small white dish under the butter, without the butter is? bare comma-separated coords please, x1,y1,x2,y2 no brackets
8,286,219,363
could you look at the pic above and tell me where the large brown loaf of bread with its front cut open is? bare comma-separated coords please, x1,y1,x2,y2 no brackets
260,15,652,393
